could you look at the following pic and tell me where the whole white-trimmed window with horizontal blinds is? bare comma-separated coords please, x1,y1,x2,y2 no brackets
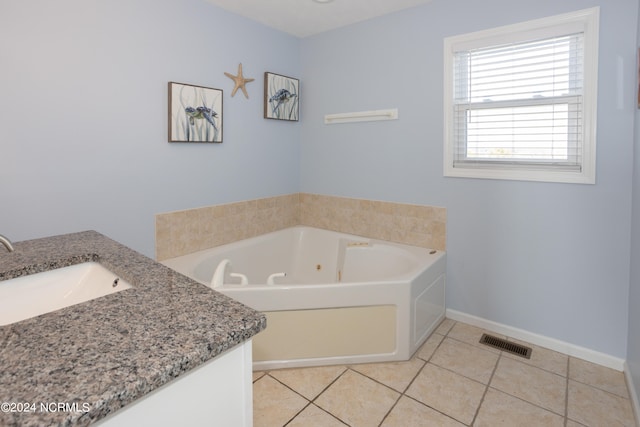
444,8,598,184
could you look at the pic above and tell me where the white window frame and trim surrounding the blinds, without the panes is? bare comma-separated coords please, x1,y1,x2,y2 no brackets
444,7,599,184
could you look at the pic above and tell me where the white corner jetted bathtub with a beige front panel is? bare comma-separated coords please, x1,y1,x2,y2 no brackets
162,226,446,370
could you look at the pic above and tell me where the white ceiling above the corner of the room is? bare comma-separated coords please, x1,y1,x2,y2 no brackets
206,0,431,38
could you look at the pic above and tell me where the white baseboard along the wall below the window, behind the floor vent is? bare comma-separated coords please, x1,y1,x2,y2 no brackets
447,308,626,372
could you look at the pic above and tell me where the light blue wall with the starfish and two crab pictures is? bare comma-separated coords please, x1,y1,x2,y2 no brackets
0,0,300,256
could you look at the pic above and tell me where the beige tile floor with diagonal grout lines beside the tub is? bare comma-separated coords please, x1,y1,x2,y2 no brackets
253,319,636,427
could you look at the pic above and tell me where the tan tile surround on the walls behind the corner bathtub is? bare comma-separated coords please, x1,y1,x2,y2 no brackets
156,193,447,261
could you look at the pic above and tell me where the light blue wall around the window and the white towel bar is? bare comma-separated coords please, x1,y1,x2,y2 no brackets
300,0,638,358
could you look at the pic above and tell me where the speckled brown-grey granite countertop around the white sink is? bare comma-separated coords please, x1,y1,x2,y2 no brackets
0,231,266,427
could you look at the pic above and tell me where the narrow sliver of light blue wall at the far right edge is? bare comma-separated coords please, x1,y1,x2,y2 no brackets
627,0,640,408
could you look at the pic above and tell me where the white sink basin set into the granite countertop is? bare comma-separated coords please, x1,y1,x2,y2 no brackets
0,262,132,325
